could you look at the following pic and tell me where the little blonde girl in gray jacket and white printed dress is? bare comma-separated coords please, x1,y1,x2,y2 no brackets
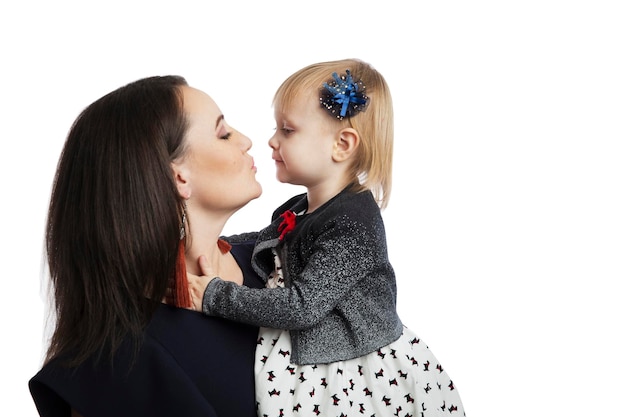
190,59,465,417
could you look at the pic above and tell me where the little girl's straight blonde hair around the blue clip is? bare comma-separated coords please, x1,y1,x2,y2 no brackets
273,59,393,209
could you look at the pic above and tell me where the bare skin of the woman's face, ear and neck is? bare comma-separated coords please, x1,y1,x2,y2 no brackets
172,87,261,284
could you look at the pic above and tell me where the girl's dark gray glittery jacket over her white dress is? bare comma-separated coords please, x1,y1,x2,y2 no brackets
202,189,402,365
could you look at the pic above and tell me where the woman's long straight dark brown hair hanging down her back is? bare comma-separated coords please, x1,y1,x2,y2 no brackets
46,76,187,366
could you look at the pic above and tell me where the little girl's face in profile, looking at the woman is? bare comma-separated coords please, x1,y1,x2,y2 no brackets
269,94,338,188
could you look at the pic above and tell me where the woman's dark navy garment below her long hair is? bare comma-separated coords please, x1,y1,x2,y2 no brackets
29,242,263,417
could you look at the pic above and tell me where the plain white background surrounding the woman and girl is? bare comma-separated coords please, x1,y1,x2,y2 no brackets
0,0,626,417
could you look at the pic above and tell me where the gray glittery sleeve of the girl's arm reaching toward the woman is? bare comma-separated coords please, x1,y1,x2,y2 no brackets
203,210,395,330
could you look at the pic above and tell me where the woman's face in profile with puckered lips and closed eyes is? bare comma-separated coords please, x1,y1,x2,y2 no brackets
177,87,261,213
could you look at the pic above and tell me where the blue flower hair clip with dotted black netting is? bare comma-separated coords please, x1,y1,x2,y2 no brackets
320,70,369,120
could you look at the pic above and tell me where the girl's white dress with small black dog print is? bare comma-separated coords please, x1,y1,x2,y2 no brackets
255,249,465,417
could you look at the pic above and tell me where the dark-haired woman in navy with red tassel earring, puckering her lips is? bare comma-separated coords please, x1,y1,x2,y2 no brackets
29,76,263,417
